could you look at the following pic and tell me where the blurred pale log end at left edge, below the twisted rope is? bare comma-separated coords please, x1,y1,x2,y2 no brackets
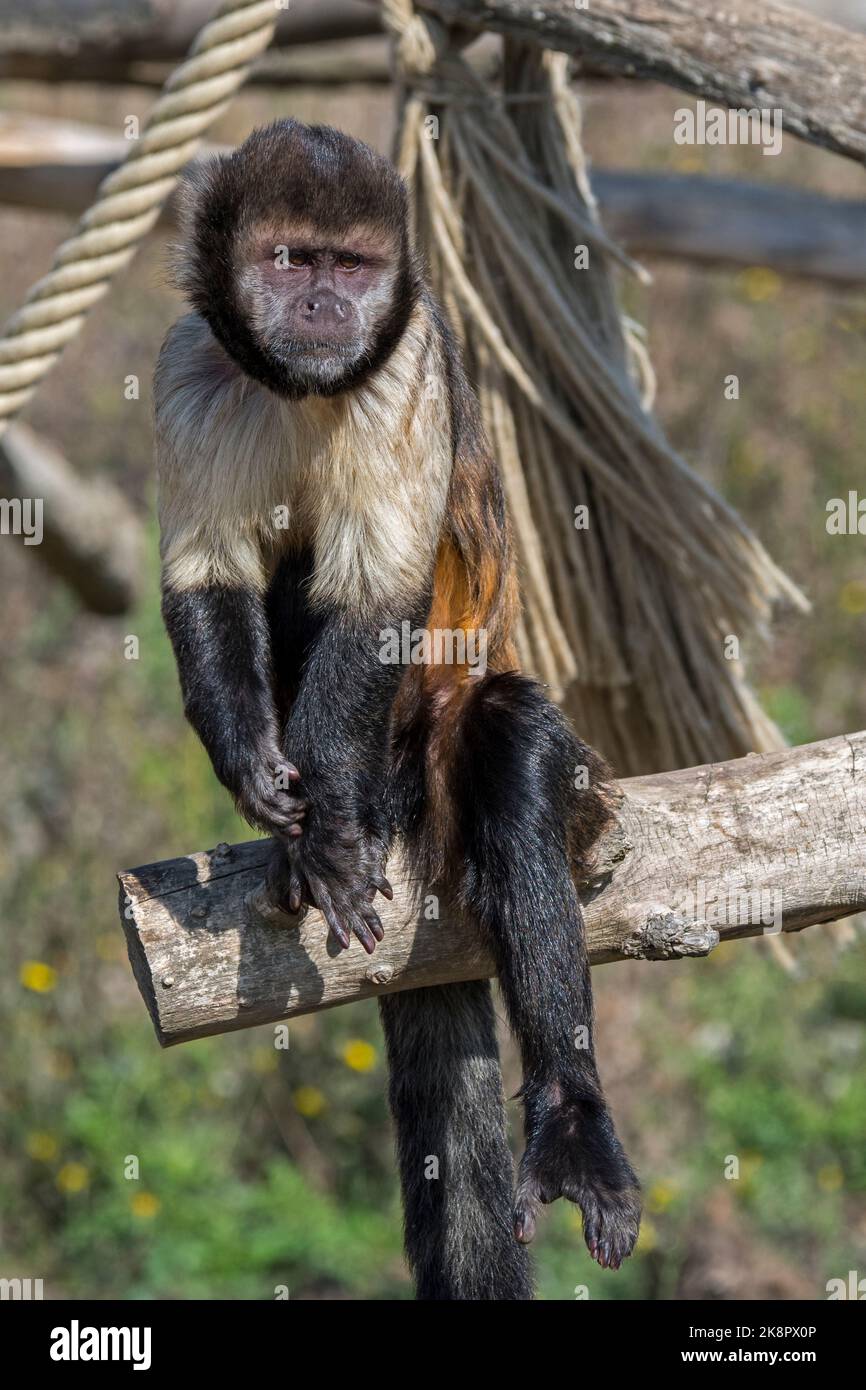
0,421,143,616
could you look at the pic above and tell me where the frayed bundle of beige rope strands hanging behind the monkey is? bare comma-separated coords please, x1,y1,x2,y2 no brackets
382,0,805,774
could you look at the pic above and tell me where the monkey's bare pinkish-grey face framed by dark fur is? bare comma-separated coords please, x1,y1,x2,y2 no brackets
238,225,399,396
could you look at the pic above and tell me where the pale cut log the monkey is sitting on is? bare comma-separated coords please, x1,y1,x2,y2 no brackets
118,733,866,1045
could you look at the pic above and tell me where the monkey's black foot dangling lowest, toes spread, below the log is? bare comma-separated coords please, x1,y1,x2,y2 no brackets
514,1102,641,1269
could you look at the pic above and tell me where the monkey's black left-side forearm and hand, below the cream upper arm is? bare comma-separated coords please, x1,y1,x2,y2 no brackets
163,587,304,835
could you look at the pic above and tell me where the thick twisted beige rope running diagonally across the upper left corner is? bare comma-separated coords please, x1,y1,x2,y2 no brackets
0,0,278,431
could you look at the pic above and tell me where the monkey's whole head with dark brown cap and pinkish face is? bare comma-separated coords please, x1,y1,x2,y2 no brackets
178,121,420,398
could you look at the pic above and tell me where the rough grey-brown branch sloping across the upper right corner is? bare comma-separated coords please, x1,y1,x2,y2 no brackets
418,0,866,160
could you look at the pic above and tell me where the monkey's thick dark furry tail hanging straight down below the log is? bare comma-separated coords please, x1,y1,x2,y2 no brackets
379,980,532,1300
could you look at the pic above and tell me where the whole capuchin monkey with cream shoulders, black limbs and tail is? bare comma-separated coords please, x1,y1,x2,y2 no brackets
156,121,639,1300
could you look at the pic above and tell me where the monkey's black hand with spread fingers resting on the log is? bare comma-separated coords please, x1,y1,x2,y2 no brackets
267,811,393,955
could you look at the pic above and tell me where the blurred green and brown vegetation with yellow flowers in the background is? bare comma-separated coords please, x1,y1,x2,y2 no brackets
0,73,866,1300
